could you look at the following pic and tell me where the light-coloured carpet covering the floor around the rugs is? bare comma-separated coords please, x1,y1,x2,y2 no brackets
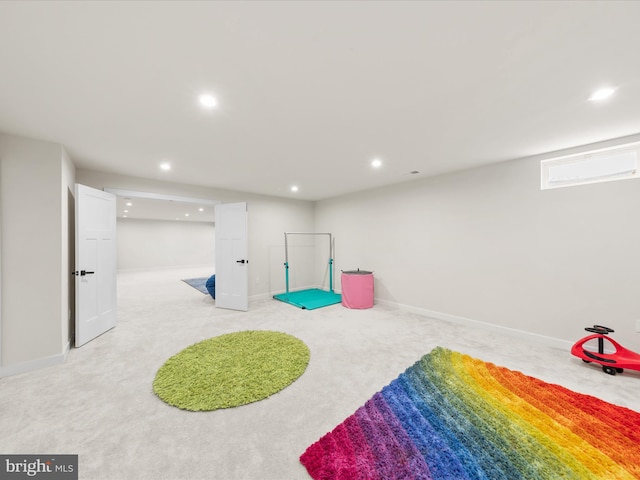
0,268,640,480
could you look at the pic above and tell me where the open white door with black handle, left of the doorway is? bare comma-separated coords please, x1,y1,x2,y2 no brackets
74,184,117,347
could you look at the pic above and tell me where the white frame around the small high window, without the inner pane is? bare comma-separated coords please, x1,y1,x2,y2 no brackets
540,142,640,190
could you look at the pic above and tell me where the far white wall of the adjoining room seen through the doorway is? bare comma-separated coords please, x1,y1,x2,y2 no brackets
117,218,215,274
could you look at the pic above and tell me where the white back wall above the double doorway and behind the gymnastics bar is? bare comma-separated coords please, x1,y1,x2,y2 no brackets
76,169,314,297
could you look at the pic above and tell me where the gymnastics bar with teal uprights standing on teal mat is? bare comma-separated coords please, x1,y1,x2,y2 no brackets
273,232,342,310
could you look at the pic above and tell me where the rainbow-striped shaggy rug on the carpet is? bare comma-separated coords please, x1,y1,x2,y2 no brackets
300,347,640,480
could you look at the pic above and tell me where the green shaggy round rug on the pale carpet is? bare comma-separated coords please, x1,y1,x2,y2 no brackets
153,330,310,412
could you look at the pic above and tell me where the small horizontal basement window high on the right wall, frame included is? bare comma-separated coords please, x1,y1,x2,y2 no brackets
540,143,640,190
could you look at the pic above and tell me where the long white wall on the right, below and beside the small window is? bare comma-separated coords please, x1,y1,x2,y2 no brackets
316,139,640,350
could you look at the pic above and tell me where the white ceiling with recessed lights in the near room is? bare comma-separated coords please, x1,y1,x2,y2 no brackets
0,1,640,200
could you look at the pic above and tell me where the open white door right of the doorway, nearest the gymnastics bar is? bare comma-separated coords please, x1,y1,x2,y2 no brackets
216,202,249,312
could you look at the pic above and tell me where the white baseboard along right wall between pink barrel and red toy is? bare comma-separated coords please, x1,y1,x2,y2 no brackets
375,298,572,350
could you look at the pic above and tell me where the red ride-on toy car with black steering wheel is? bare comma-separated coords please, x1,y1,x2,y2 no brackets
571,325,640,375
